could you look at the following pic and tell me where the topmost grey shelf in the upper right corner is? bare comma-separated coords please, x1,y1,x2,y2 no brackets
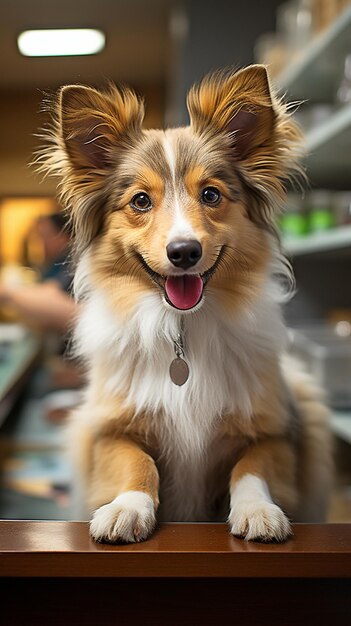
275,7,351,102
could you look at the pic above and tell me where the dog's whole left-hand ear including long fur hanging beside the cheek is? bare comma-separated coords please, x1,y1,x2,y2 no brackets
33,85,144,251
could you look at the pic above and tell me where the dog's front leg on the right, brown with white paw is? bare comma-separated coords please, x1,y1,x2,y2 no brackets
228,438,298,541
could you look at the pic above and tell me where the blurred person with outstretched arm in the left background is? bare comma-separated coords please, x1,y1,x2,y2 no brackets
0,212,84,422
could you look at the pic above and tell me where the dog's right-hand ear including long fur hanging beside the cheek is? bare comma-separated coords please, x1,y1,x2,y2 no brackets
188,65,303,230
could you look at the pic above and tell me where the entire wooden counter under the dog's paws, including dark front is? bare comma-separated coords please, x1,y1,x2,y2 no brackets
0,521,351,626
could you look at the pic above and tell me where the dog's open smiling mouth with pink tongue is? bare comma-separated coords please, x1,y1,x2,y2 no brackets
137,246,224,311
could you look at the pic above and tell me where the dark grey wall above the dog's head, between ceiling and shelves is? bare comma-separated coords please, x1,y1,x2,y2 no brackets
168,0,282,124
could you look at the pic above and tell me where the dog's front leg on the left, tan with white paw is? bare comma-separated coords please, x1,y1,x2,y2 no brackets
90,437,159,542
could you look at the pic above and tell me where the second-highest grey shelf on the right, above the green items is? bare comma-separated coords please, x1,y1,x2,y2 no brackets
305,104,351,189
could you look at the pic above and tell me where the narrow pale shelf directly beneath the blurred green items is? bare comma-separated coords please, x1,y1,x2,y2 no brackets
283,225,351,256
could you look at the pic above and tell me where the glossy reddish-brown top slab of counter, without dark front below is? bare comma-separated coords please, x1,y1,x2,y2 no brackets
0,521,351,576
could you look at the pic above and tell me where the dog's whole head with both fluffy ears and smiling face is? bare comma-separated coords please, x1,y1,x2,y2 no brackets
39,65,300,312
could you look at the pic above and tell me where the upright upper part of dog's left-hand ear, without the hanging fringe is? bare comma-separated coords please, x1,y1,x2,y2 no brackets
59,85,144,170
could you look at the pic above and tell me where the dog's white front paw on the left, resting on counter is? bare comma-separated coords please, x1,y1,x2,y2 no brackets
90,491,156,543
